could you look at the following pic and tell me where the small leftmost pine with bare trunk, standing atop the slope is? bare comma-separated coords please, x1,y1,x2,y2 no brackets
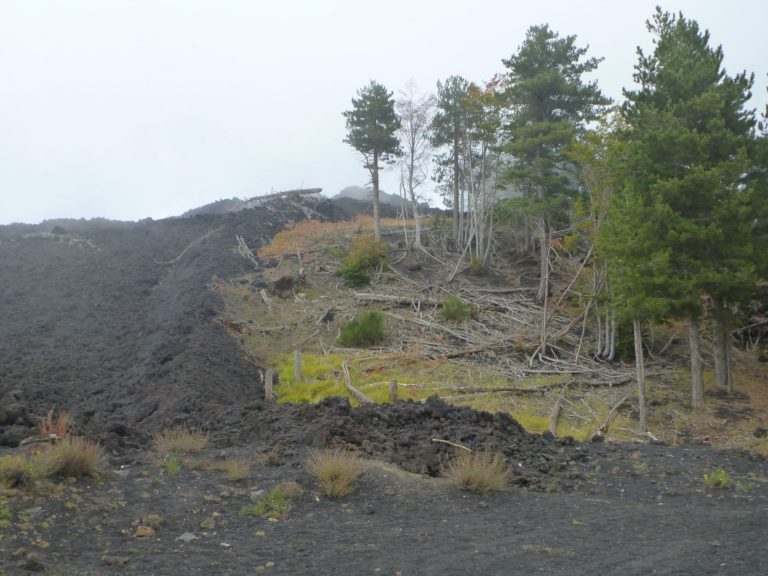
343,80,402,240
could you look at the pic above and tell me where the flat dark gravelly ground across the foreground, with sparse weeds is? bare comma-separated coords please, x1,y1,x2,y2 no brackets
0,445,768,576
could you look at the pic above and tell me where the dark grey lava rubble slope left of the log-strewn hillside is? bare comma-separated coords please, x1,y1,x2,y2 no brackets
0,197,336,448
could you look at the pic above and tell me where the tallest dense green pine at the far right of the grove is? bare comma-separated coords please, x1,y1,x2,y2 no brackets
612,8,756,407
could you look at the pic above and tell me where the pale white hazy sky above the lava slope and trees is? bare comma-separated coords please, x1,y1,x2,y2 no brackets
0,0,768,224
